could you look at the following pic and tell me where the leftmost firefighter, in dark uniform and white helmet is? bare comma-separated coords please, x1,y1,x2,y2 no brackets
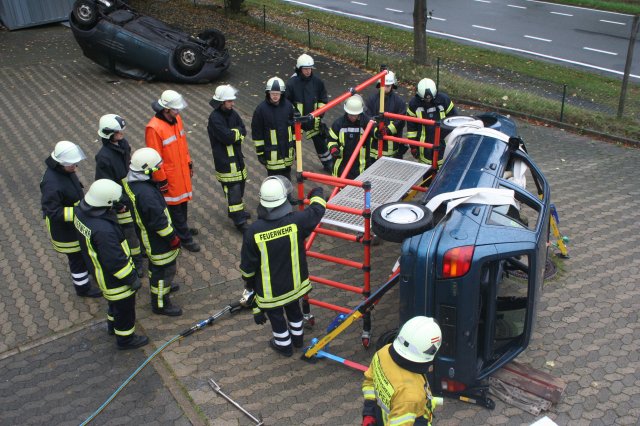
40,141,102,297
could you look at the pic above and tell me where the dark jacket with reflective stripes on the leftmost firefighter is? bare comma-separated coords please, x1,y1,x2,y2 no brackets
40,157,84,253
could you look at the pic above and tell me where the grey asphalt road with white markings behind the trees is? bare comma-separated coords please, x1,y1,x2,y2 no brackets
284,0,640,80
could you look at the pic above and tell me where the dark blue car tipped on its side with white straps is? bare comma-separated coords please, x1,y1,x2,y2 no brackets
372,115,551,408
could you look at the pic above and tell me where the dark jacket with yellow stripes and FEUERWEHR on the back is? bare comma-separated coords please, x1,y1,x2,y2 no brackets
240,197,326,309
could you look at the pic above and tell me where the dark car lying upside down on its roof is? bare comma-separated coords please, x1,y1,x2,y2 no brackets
69,0,231,83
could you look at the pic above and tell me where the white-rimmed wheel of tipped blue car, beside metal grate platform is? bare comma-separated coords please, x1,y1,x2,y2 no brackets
371,202,433,243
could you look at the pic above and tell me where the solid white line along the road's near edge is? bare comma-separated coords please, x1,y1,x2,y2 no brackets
284,0,640,79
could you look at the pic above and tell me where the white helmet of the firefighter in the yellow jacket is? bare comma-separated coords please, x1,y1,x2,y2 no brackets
393,316,442,363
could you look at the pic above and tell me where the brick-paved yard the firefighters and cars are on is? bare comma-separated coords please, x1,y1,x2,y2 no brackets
0,5,640,425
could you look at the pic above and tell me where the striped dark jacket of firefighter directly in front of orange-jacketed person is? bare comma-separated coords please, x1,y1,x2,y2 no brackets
124,180,180,265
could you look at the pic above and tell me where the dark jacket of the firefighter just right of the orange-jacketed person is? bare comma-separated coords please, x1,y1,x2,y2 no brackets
207,107,247,182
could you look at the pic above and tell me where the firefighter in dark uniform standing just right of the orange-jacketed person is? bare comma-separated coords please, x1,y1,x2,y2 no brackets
207,84,251,232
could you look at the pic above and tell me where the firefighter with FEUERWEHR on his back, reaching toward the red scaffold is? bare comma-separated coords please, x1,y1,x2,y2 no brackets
240,176,326,357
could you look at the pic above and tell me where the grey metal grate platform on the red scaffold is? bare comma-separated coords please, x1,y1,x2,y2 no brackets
322,157,431,232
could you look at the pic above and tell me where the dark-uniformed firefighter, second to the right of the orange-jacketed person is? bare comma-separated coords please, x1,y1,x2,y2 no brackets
251,77,295,181
